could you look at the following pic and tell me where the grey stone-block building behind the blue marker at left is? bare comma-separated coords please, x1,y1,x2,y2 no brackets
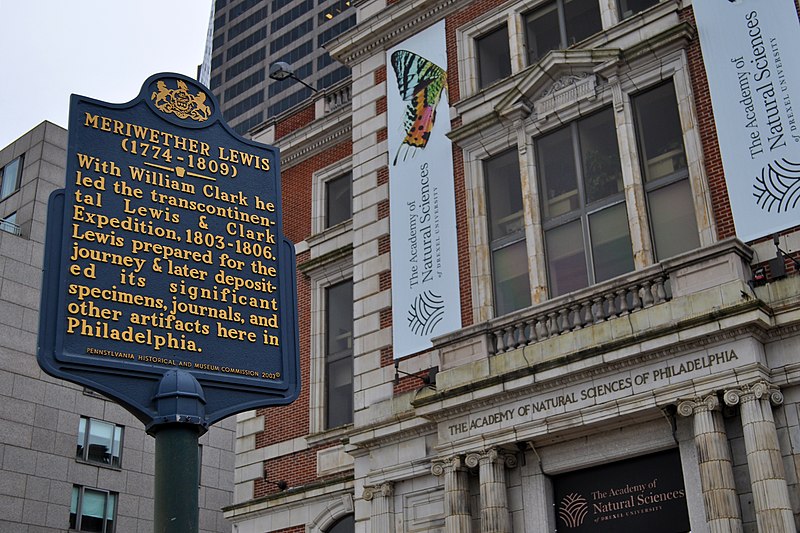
0,122,234,533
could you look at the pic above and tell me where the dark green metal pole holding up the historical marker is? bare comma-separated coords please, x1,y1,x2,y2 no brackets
153,424,200,533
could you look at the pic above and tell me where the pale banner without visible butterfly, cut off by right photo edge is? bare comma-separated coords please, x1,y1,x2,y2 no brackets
692,0,800,241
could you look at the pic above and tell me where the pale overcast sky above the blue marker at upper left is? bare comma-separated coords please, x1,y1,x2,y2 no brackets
0,0,212,148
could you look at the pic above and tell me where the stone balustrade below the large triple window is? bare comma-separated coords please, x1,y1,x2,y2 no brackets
434,239,754,370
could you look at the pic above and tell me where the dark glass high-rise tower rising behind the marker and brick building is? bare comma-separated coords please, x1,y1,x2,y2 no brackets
210,0,356,133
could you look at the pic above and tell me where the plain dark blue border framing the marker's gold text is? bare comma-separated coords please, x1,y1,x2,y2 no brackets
37,73,300,426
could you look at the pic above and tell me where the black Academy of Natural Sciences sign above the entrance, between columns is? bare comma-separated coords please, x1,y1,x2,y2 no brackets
553,449,690,533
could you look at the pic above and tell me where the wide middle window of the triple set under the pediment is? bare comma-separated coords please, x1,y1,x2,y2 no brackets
536,108,633,296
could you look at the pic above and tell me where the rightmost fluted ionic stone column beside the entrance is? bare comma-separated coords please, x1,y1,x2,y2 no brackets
724,381,796,533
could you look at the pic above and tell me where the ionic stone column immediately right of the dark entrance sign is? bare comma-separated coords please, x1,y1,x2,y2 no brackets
678,394,742,533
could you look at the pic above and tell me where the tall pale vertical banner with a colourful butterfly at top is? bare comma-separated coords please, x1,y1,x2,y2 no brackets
386,21,461,358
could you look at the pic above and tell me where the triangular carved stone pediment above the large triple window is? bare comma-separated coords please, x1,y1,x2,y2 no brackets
495,49,622,120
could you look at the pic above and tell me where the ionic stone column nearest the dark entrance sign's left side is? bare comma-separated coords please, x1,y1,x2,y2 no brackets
465,448,511,533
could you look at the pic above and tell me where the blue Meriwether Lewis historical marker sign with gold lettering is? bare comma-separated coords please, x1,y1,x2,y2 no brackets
38,73,300,426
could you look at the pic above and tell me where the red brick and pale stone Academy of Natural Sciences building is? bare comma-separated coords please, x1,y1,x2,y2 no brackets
220,0,800,533
